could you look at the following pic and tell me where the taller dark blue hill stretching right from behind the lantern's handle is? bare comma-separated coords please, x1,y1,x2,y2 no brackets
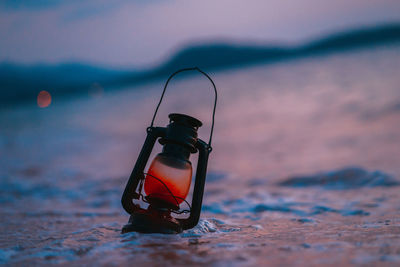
145,24,400,76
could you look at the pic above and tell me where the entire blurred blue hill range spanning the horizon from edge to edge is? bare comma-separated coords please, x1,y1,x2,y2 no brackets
0,24,400,106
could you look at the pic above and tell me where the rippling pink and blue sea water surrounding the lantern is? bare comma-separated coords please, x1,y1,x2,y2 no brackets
0,46,400,266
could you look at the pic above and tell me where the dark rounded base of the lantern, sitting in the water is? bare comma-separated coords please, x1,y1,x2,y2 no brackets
122,210,183,234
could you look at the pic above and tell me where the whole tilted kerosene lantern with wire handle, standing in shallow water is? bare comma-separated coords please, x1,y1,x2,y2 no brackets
121,67,217,233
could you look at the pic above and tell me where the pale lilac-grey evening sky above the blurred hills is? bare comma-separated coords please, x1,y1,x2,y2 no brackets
0,0,400,68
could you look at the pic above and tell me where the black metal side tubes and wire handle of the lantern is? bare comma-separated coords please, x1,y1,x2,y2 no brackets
121,67,217,230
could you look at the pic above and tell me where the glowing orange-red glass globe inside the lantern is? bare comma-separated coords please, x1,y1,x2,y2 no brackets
144,154,192,206
